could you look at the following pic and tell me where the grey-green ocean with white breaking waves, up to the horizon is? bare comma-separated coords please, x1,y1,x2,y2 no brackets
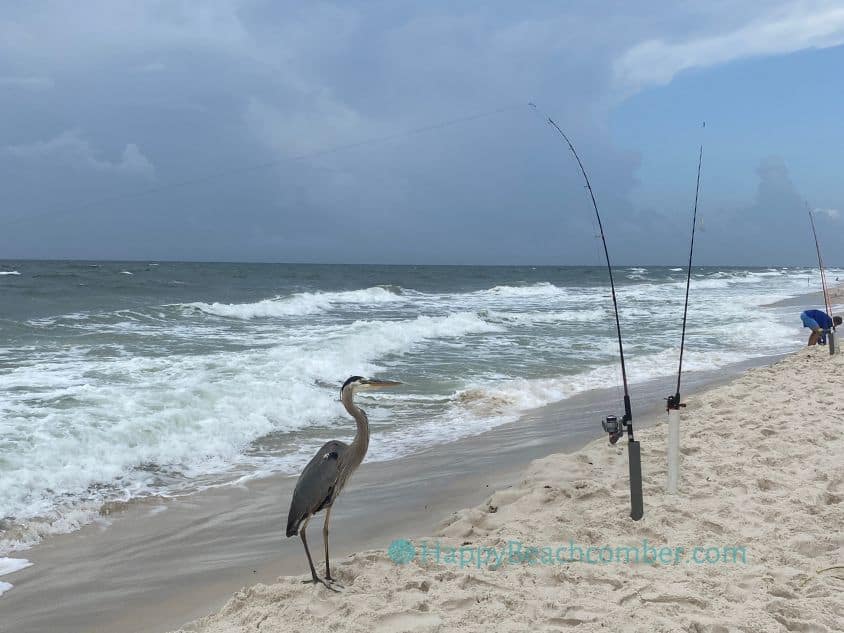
0,261,828,554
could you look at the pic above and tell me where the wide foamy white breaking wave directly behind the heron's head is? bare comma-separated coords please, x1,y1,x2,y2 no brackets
0,312,502,551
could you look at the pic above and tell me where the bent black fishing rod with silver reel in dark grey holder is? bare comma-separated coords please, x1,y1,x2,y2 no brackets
528,103,645,521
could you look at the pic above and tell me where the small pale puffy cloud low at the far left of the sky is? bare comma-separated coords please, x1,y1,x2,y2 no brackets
3,130,155,178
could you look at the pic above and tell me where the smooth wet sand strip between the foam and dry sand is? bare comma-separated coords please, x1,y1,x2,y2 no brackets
0,357,776,633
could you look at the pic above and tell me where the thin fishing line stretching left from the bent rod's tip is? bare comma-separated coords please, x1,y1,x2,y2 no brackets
3,103,524,226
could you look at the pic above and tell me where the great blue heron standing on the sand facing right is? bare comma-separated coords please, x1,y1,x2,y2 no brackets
287,376,401,589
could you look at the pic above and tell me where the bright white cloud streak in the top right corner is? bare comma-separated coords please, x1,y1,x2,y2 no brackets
613,4,844,95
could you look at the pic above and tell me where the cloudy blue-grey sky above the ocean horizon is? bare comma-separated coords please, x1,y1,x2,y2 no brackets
0,0,844,266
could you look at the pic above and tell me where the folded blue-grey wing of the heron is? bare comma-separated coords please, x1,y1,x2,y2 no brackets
287,440,349,536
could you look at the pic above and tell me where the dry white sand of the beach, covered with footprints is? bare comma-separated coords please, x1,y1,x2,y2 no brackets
173,347,844,633
